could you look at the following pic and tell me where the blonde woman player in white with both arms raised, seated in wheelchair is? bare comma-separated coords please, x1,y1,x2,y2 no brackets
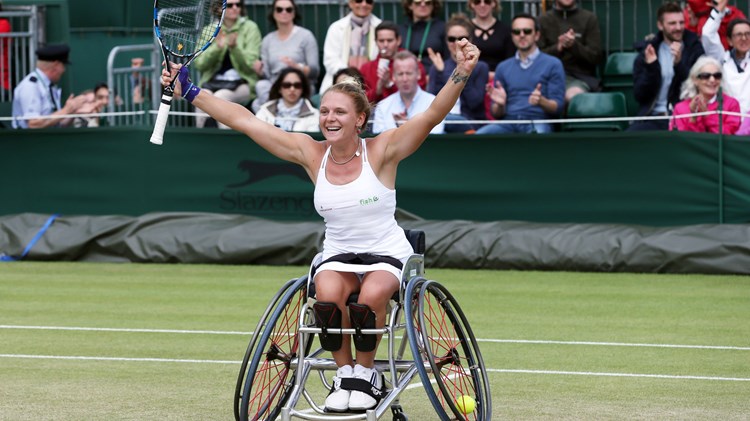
162,39,479,412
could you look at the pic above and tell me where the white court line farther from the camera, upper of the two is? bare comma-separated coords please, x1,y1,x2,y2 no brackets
0,325,750,351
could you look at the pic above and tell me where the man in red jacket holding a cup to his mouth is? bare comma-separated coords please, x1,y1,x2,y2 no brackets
359,21,427,104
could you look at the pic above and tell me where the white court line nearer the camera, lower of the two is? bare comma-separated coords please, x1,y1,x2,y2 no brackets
0,354,750,382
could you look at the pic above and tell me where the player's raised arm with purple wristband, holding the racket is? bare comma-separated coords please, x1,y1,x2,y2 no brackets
162,64,320,179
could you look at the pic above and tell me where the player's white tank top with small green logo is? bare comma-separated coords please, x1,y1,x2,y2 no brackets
314,139,413,261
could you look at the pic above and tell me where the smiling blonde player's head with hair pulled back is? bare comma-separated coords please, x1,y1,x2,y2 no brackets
320,90,365,142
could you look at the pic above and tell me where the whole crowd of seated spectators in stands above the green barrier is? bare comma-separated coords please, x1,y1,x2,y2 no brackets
8,0,750,134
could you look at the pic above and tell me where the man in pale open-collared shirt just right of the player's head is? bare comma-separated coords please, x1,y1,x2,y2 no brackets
372,51,445,134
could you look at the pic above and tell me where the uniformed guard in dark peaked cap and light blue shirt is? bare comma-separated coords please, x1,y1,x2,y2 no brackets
13,44,85,129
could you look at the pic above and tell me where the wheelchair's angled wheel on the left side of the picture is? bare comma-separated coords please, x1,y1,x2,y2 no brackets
235,276,309,421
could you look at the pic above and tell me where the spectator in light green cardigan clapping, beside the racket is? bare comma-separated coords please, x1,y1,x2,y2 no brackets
193,0,261,129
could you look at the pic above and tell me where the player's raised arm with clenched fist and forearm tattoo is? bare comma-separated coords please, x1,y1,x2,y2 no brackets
378,39,480,163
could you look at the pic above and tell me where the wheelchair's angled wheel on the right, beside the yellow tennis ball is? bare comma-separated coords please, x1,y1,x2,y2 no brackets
405,279,492,421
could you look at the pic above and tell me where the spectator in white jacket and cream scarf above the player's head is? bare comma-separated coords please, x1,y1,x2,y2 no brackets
320,0,381,94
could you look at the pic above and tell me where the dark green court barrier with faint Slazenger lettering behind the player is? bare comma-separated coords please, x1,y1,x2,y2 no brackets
0,127,750,226
